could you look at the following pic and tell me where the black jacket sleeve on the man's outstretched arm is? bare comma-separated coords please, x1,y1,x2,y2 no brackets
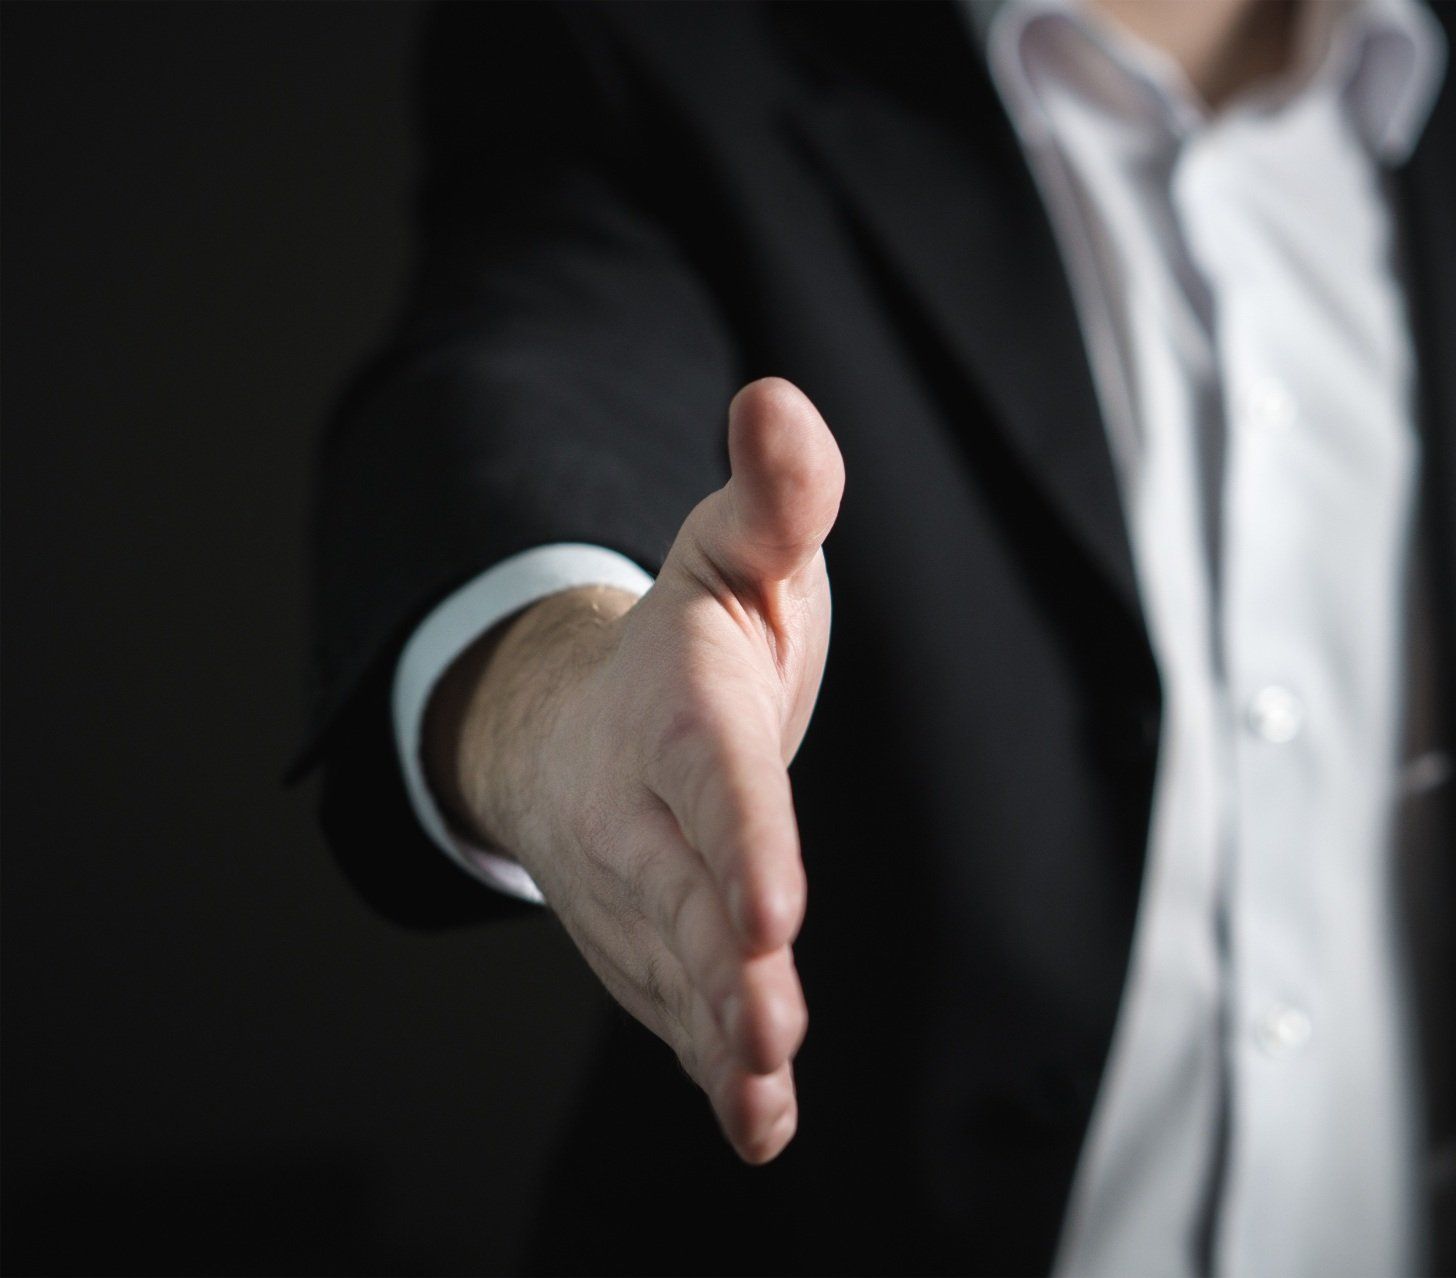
288,3,738,926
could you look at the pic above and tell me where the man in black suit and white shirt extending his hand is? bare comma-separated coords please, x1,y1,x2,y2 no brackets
298,0,1456,1274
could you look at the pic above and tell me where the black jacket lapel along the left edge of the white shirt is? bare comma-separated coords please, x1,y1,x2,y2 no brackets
789,4,1140,616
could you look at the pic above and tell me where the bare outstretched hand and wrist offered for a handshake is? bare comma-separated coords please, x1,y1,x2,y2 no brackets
427,378,844,1163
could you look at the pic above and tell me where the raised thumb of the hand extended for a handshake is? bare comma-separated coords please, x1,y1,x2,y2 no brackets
695,377,844,585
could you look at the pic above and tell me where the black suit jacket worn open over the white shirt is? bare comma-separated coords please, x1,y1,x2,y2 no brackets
289,4,1456,1272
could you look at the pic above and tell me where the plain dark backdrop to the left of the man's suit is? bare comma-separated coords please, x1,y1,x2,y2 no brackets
0,3,606,1274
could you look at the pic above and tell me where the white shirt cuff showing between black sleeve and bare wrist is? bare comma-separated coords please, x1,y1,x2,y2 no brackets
392,543,652,904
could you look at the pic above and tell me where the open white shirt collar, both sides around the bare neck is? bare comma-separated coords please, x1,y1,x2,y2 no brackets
958,0,1447,164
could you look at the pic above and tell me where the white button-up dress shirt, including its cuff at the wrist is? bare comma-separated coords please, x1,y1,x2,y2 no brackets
395,0,1444,1278
